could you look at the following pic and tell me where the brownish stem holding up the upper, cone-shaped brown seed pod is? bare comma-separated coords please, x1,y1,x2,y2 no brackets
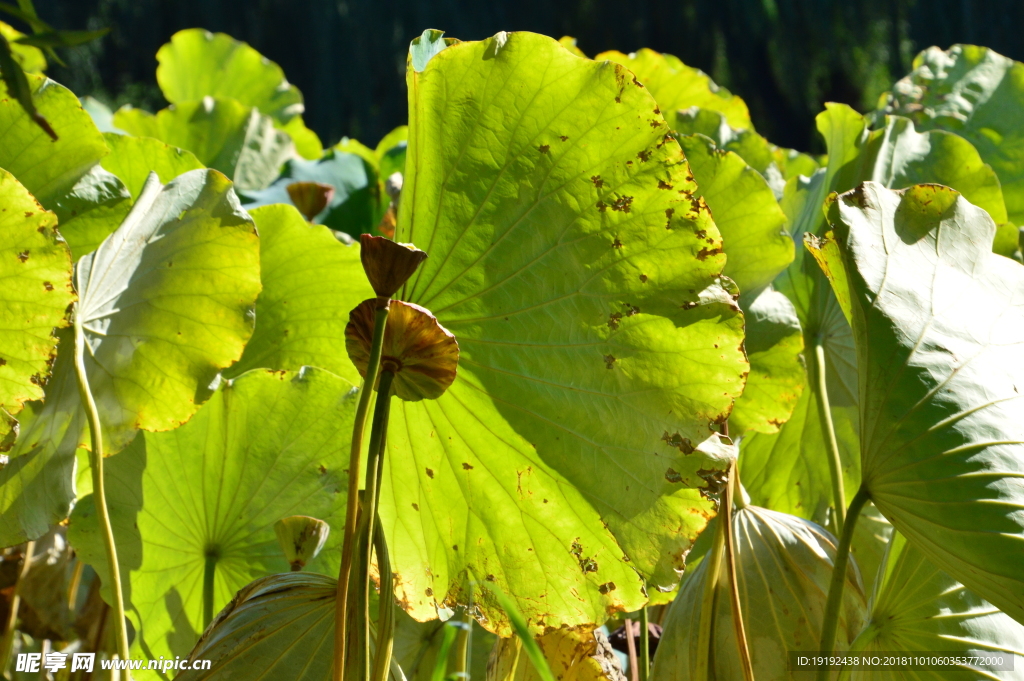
334,303,390,681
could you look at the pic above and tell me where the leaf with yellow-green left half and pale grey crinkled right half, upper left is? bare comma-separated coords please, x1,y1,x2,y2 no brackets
114,97,295,190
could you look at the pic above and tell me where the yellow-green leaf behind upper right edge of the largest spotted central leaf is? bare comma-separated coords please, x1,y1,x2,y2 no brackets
679,134,794,304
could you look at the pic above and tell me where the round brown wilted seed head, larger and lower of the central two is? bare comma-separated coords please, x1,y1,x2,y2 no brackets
345,298,459,401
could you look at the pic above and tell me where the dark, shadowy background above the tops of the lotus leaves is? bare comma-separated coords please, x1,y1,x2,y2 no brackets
22,0,1024,152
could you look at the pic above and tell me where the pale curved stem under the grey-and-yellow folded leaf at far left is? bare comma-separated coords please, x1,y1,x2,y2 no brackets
75,310,128,659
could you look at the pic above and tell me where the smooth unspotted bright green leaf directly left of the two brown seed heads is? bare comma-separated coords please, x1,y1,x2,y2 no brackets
225,205,374,383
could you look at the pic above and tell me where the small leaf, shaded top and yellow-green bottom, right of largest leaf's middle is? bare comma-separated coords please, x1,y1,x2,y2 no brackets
729,289,806,435
